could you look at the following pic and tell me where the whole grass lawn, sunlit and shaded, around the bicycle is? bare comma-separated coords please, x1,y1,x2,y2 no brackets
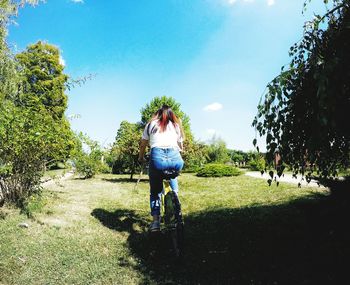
0,174,350,284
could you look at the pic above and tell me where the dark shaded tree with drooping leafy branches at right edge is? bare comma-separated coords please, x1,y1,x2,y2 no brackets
253,0,350,179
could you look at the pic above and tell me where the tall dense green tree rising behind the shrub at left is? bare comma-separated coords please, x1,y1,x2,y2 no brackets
16,41,68,119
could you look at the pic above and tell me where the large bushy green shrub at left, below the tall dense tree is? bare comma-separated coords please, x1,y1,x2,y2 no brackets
0,102,74,204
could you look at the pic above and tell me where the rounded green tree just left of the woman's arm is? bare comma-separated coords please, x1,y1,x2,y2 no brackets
111,121,142,179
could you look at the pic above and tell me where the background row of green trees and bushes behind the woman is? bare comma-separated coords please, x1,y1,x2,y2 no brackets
102,96,265,179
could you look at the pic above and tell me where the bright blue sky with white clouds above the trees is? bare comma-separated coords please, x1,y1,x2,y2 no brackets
8,0,325,151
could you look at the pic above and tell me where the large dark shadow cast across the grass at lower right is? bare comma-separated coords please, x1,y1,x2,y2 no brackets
91,179,350,285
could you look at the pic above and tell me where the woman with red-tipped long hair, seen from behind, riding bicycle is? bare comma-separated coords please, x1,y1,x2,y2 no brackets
139,105,184,232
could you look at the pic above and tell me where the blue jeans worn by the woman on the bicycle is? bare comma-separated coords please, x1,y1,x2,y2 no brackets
149,147,184,216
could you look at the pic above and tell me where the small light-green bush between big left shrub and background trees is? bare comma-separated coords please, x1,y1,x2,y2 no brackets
72,133,106,179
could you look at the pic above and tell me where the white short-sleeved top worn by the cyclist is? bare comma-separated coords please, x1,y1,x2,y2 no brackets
142,120,183,149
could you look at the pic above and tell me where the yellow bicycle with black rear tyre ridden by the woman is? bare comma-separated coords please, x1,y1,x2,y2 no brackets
134,160,184,258
